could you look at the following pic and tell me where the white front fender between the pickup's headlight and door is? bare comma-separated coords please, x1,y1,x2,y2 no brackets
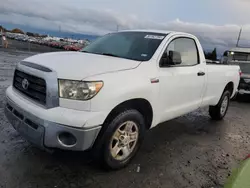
91,69,159,122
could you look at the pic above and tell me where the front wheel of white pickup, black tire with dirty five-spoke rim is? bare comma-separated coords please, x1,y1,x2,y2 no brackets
94,110,146,170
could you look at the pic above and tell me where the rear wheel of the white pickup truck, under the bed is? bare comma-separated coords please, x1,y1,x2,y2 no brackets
209,90,231,120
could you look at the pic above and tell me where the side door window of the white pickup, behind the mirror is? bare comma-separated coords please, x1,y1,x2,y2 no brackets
163,38,199,66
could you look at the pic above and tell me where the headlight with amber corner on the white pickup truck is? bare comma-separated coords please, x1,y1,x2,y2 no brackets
58,79,103,100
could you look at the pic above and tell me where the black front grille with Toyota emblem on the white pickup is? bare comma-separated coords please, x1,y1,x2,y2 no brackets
13,70,46,105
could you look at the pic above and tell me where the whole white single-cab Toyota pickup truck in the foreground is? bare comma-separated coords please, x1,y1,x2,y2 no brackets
5,30,240,169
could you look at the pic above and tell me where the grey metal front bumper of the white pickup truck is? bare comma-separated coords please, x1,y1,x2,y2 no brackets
5,98,101,151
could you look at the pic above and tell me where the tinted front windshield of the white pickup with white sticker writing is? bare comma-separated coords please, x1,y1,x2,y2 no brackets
81,32,166,61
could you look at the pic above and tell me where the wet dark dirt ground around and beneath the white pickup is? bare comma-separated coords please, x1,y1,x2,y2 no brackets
0,48,250,188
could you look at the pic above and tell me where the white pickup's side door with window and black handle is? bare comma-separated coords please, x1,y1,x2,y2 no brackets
159,37,205,121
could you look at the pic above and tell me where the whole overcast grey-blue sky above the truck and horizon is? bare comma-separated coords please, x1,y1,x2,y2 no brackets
0,0,250,53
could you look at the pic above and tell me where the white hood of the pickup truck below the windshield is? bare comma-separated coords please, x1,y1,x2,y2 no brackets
24,52,141,80
